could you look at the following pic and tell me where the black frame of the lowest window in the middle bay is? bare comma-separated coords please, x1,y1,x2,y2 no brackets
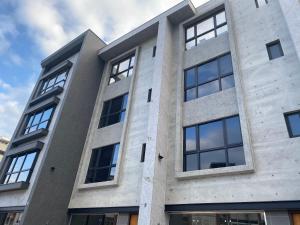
85,143,120,184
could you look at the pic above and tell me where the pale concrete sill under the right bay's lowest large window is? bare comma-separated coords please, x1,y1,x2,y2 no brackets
175,165,254,180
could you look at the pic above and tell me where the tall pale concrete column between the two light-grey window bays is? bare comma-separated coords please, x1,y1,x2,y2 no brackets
138,17,172,225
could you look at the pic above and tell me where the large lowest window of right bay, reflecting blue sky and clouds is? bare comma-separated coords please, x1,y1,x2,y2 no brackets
184,116,245,171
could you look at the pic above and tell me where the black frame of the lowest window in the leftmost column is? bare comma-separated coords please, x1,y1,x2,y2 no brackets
1,150,39,185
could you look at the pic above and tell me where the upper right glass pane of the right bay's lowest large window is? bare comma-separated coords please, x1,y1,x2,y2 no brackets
225,116,242,145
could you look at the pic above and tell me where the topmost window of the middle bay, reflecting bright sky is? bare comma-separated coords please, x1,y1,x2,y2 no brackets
109,55,135,84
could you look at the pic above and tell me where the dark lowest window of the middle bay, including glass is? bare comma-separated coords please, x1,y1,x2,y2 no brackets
85,144,119,183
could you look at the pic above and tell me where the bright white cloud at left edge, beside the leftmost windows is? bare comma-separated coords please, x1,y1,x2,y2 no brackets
0,79,34,138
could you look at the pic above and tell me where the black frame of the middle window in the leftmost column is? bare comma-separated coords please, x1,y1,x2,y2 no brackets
21,105,56,135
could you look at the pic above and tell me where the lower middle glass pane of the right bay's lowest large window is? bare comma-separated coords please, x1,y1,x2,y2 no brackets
200,150,226,170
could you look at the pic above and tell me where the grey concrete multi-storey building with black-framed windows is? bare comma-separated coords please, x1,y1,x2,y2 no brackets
0,0,300,225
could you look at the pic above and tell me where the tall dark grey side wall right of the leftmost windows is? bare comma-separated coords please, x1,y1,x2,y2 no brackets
21,33,103,225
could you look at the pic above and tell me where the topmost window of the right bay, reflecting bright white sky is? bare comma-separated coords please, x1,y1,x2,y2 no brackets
185,10,227,49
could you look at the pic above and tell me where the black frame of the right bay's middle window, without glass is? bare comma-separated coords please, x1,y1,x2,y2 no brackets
183,52,235,102
